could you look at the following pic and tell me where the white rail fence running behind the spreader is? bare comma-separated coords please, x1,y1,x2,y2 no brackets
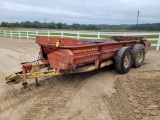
0,30,160,51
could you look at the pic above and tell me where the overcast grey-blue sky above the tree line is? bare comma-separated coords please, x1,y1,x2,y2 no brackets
0,0,160,24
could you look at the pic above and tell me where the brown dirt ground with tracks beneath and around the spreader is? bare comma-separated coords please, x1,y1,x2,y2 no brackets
0,37,160,120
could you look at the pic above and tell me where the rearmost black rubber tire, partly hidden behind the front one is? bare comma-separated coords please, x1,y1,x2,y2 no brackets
133,44,145,68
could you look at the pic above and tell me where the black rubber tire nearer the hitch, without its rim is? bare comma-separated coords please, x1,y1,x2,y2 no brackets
115,47,133,74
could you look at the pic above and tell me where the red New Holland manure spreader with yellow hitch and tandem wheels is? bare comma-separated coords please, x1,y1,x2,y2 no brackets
6,36,151,88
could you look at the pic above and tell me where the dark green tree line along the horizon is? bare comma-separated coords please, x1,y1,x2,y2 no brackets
0,21,160,30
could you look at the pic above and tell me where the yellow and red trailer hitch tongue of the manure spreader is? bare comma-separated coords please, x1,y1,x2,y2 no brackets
6,63,63,89
